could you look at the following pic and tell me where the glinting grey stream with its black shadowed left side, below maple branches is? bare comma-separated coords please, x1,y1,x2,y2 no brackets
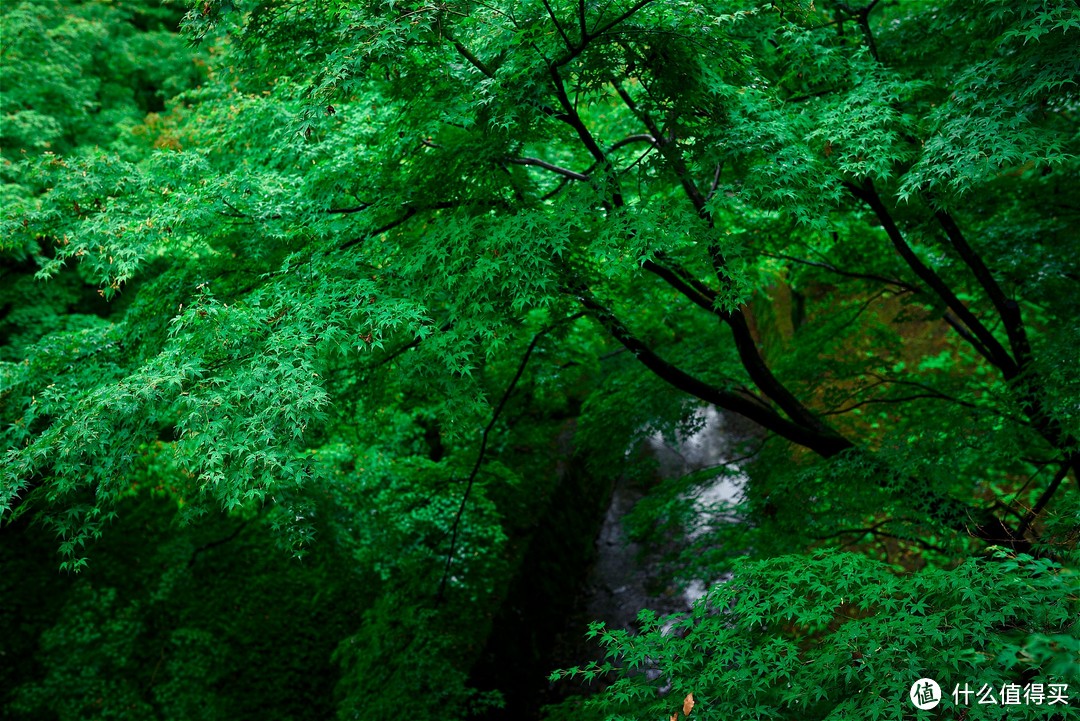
471,407,758,721
